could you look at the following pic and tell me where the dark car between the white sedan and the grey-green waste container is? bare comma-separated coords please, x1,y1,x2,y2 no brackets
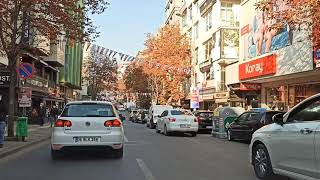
193,111,213,131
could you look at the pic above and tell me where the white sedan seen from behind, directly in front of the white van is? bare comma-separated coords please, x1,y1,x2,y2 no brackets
156,109,199,136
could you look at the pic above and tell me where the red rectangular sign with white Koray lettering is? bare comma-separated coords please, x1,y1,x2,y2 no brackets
239,54,277,80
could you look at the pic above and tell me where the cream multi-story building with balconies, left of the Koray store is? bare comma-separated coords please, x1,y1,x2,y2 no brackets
178,0,240,109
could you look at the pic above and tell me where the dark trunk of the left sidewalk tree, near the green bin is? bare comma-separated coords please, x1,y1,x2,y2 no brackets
8,55,17,137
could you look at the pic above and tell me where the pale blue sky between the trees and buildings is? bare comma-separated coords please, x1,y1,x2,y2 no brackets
93,0,165,56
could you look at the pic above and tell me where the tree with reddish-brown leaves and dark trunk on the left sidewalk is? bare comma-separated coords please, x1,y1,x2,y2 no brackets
0,0,109,136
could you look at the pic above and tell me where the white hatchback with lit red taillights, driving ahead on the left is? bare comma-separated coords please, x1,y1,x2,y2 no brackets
51,101,124,159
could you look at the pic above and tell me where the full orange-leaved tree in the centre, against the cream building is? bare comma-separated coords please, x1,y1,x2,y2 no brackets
141,25,191,104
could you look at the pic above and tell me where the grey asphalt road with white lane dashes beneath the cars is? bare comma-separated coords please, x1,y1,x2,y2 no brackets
0,122,256,180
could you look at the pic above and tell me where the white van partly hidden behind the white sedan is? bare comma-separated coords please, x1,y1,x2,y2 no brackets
147,105,173,129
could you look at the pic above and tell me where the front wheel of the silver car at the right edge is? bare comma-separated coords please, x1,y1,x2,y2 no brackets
252,144,274,180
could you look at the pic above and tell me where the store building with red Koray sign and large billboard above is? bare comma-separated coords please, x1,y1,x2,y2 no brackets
227,0,320,110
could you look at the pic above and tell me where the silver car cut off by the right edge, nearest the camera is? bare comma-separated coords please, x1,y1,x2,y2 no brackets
249,94,320,180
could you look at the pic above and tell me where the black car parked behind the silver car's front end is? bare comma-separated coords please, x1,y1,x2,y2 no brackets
227,109,284,141
